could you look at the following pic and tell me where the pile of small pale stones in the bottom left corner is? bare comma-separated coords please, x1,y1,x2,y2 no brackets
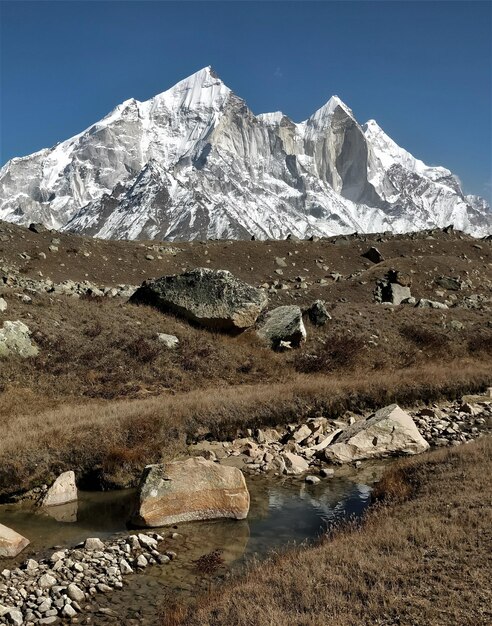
0,533,176,626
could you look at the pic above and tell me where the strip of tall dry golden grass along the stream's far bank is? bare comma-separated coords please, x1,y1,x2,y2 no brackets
0,360,490,496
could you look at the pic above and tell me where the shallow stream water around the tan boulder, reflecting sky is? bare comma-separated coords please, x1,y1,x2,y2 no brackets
0,469,379,624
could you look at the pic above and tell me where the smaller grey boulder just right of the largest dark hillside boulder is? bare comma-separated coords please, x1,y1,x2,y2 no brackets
256,306,306,348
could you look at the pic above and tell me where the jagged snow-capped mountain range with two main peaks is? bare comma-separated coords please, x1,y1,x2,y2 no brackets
0,67,492,240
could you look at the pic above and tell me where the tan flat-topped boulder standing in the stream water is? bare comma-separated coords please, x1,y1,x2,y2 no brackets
133,457,250,527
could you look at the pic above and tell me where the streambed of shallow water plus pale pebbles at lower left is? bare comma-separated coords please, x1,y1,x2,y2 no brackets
0,470,383,624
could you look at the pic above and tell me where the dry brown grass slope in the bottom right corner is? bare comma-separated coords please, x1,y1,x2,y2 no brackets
161,438,492,626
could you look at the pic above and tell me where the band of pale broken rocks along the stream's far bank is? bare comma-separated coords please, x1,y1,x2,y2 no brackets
191,398,492,476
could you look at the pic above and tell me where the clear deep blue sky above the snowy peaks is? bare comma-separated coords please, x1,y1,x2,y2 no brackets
0,0,492,200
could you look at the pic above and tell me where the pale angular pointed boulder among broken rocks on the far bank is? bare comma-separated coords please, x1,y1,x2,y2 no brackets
325,404,429,463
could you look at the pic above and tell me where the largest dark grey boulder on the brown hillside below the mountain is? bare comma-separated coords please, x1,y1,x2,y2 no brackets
131,268,268,331
